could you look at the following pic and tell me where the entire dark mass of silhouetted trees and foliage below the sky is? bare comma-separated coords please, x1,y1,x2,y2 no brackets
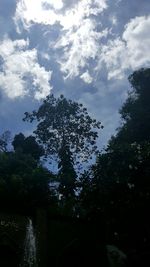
0,69,150,267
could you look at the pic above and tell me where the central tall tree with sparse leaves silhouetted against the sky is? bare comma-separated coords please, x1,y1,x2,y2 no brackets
24,94,102,200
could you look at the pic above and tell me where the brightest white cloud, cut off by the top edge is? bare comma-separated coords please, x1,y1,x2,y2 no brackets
14,0,107,29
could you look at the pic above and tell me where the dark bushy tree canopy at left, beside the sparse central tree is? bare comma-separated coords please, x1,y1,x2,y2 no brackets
0,133,54,212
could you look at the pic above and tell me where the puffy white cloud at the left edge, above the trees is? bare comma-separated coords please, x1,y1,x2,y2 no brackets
0,37,52,99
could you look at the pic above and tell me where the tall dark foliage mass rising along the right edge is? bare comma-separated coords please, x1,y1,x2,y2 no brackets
81,69,150,249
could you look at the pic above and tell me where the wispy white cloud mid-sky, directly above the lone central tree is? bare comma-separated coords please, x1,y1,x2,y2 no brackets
55,19,107,78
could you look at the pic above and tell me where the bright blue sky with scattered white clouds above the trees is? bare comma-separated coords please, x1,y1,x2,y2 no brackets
0,0,150,147
